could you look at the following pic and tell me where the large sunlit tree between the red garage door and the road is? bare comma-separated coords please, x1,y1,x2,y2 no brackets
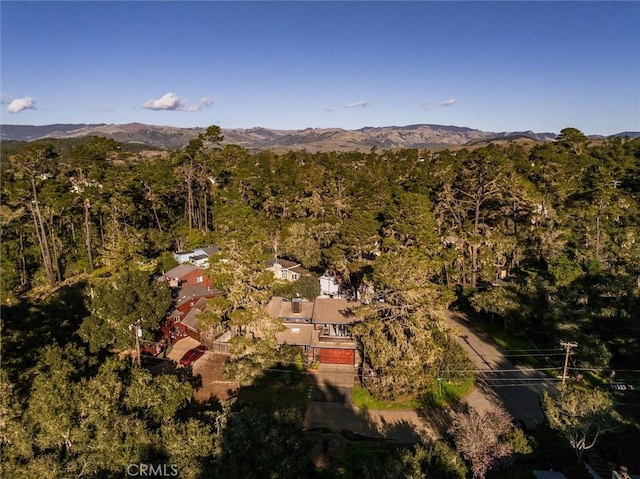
354,248,453,400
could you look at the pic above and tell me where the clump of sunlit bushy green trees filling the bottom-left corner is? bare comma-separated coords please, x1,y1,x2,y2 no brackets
2,346,200,477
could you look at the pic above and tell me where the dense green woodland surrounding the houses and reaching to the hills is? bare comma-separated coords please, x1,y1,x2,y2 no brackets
0,127,640,477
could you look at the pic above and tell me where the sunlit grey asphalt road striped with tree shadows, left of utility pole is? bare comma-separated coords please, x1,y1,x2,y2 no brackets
447,311,557,428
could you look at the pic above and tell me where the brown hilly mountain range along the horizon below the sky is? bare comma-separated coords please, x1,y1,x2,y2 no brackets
0,123,640,152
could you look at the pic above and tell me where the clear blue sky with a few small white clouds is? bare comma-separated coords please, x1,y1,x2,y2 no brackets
0,0,640,134
